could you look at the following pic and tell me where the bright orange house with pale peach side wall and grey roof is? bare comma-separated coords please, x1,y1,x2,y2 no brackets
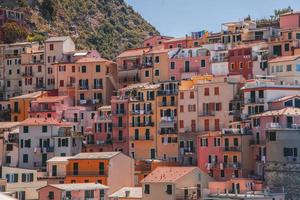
65,152,134,194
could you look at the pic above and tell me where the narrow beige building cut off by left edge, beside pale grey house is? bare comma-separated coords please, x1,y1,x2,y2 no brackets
0,122,19,167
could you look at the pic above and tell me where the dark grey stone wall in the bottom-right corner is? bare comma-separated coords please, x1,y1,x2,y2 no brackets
265,163,300,199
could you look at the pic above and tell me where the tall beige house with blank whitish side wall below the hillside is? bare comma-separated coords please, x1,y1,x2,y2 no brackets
44,36,75,90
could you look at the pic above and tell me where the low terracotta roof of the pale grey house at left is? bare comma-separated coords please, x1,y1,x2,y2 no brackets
20,118,71,126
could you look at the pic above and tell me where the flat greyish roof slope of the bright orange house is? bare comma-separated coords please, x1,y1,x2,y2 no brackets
69,152,121,160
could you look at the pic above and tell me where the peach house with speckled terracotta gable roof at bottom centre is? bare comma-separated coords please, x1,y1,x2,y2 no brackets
142,167,212,200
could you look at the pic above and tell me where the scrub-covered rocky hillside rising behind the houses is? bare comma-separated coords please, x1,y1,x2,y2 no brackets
0,0,158,59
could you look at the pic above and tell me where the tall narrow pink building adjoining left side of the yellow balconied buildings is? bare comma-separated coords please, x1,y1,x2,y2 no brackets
111,96,129,155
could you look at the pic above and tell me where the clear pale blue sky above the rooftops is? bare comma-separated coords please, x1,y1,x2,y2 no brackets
125,0,300,37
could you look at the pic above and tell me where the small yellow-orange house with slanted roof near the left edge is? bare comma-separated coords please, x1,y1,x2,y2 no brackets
9,91,47,122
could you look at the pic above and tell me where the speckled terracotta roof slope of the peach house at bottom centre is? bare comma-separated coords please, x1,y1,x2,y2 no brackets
142,167,198,183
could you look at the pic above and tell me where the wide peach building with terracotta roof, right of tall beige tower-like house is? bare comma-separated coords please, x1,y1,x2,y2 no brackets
53,57,117,106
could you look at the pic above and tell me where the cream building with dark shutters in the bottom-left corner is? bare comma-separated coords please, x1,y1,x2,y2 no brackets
0,166,47,200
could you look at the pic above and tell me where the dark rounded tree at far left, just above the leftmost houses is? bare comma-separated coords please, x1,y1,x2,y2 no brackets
3,22,28,43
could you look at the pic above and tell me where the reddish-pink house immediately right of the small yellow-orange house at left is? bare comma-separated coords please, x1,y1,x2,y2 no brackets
29,96,74,120
